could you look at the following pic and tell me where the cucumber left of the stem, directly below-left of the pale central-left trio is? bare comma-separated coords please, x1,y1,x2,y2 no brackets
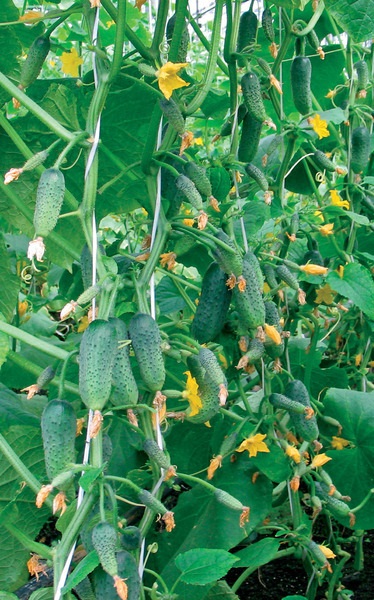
41,399,77,489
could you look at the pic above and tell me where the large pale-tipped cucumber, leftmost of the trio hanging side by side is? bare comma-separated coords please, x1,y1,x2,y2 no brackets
79,319,117,410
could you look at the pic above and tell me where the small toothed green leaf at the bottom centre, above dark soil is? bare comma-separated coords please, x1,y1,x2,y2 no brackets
175,548,238,585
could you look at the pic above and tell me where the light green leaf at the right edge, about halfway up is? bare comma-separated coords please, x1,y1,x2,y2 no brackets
326,263,374,319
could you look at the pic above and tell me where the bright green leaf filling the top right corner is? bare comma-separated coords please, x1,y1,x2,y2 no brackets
325,0,374,42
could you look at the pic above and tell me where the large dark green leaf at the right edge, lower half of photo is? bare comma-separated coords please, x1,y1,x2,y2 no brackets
324,388,374,529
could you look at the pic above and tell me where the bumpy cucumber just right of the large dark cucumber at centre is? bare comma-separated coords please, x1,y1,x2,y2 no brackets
233,262,265,333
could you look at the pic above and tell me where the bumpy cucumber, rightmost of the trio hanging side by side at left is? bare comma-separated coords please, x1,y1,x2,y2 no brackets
129,313,165,392
